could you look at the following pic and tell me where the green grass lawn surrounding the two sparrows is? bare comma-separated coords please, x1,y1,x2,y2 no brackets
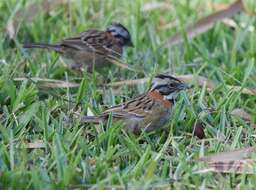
0,0,256,189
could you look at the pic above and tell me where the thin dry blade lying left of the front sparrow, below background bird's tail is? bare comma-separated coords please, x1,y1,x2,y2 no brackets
13,77,80,88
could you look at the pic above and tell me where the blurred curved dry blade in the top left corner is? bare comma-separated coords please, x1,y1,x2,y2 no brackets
6,0,66,39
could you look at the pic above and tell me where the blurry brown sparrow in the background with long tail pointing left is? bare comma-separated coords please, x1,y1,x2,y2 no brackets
23,23,133,72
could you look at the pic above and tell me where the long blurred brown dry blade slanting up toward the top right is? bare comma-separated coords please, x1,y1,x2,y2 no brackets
165,0,243,47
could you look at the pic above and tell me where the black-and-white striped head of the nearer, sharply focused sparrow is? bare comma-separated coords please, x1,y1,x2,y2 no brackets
150,74,189,101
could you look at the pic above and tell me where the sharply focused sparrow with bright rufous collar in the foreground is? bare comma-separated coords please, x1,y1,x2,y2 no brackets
82,74,188,134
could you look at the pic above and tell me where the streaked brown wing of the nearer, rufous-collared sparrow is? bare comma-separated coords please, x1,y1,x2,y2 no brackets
103,94,155,118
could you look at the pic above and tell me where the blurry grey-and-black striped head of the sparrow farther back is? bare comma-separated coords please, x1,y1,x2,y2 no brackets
107,23,132,45
